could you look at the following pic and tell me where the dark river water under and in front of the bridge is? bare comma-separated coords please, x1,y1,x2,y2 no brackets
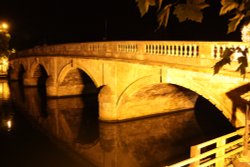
0,80,233,167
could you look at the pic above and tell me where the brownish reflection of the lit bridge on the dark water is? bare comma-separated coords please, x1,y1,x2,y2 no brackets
8,83,216,167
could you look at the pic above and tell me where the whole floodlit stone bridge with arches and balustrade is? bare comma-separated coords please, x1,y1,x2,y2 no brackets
9,41,250,127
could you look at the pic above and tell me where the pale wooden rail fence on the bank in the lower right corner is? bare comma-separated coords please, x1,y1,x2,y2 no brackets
165,128,245,167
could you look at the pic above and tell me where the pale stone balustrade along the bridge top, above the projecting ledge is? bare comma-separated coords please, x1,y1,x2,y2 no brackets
11,41,249,59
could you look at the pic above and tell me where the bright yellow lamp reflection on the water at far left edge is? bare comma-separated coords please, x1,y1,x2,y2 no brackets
0,79,13,131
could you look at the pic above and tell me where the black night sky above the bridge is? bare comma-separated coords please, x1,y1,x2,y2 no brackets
0,0,240,50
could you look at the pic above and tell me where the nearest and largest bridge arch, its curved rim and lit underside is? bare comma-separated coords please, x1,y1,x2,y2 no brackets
116,72,237,126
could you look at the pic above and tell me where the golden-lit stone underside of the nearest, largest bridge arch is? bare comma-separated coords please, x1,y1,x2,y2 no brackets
116,75,198,120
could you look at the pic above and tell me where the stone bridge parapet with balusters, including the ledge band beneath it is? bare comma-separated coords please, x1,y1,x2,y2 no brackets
10,41,250,75
